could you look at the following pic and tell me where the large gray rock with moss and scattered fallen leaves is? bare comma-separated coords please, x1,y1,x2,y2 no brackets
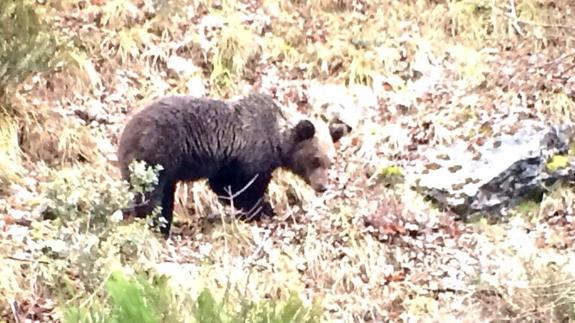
411,120,574,217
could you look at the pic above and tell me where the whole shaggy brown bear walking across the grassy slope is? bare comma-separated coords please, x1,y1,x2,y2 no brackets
118,93,340,236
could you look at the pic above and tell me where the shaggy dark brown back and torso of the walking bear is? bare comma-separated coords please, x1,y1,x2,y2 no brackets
119,95,281,180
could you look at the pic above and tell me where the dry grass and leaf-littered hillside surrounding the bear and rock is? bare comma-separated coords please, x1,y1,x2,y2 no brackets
0,0,575,322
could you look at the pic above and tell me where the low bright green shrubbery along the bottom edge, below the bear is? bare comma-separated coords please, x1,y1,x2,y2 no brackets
64,271,321,323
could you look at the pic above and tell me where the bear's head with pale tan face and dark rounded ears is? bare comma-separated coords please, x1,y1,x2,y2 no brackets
286,120,346,192
